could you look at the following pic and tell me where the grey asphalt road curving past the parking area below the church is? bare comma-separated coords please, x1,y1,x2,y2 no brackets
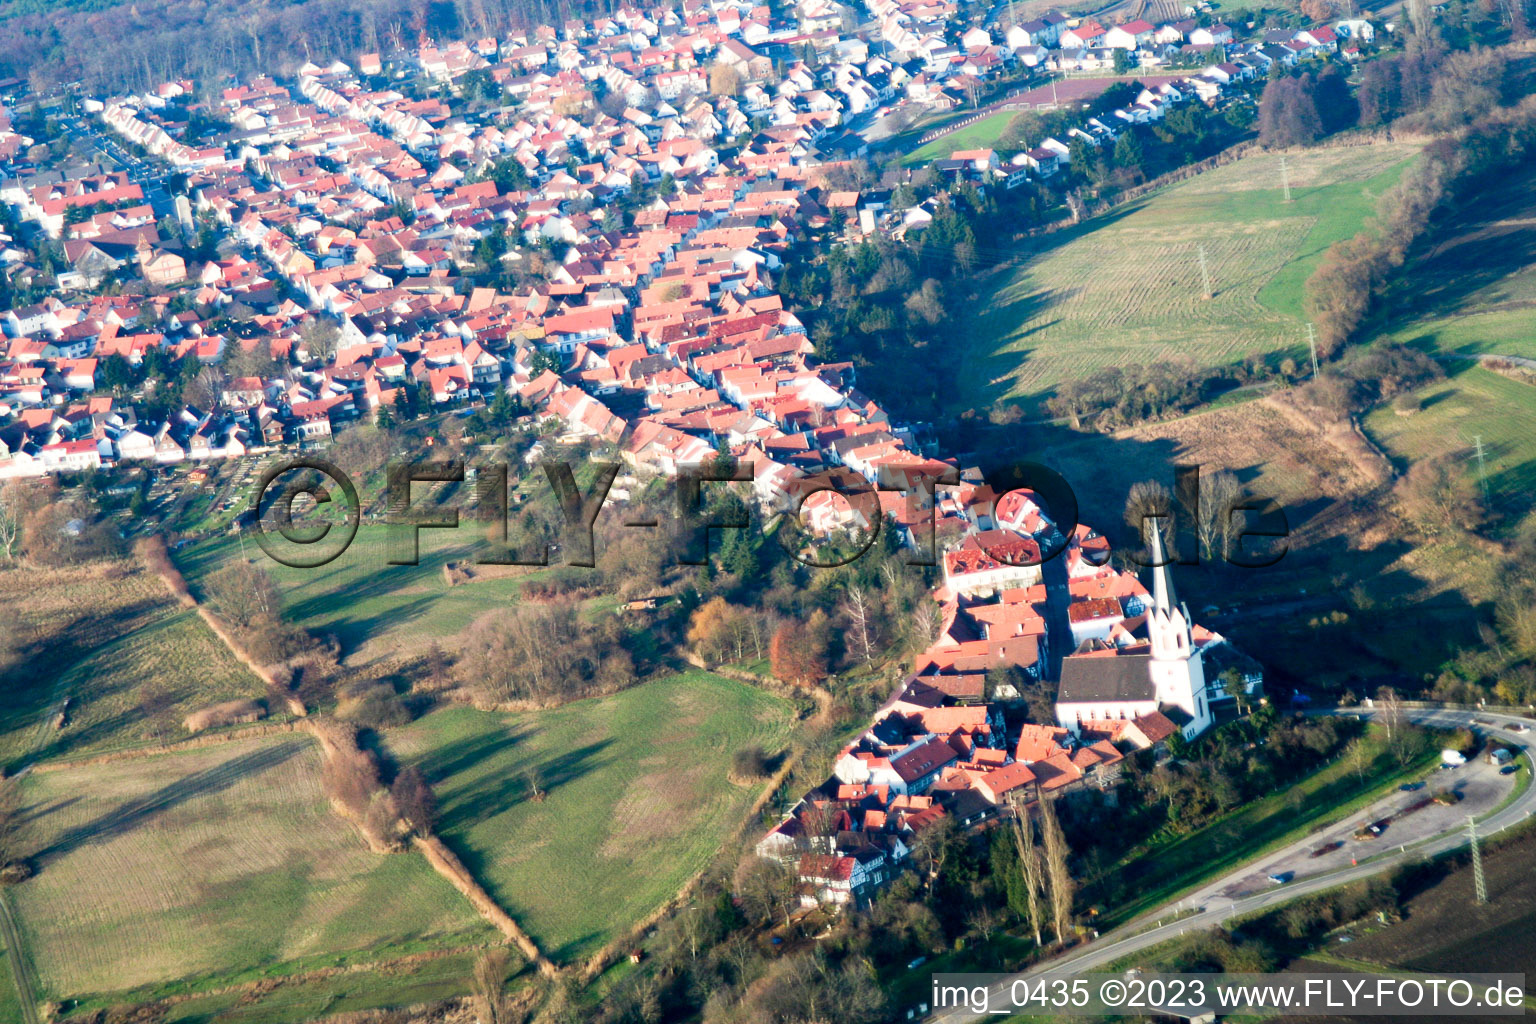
928,708,1536,1024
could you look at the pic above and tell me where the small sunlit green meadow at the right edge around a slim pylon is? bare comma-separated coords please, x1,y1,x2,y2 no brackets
1366,362,1536,510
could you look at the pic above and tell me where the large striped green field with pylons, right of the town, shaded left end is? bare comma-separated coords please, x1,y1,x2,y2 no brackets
957,144,1416,407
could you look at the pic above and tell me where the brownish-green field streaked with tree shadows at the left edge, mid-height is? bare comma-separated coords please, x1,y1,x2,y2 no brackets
0,562,263,765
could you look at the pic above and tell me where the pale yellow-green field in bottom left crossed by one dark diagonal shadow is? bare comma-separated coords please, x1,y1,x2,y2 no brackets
12,735,490,998
